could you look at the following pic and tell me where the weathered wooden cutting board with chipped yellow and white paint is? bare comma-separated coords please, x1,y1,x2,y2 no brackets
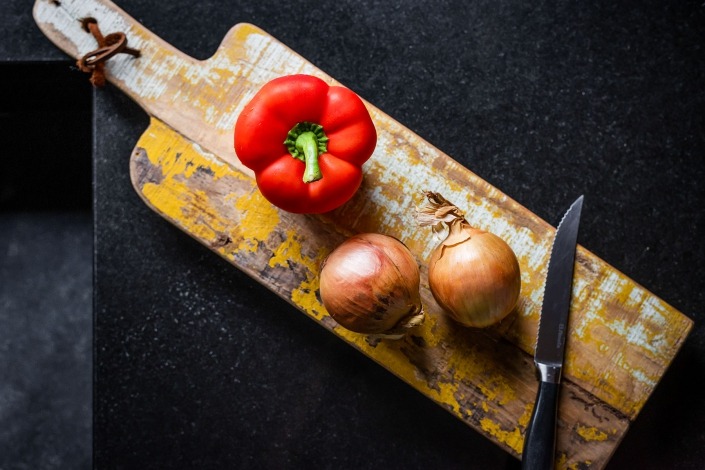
34,0,692,468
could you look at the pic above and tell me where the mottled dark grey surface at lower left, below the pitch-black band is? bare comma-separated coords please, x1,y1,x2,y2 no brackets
0,213,93,470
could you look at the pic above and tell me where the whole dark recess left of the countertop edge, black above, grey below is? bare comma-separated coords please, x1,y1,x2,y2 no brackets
0,58,93,470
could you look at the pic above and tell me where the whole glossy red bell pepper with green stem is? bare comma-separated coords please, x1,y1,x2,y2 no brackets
235,75,377,214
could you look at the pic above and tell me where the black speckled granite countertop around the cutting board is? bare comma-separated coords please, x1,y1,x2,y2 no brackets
1,0,705,469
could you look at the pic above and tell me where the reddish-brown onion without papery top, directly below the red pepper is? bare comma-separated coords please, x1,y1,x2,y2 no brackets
320,233,424,338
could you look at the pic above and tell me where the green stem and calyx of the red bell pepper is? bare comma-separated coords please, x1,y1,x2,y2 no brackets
284,121,328,183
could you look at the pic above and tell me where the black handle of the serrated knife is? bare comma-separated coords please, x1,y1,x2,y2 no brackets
521,382,560,470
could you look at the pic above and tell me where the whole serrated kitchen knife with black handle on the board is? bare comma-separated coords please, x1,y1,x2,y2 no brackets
522,196,583,470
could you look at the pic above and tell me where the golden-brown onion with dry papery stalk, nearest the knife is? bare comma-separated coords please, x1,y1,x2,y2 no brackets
418,191,521,328
